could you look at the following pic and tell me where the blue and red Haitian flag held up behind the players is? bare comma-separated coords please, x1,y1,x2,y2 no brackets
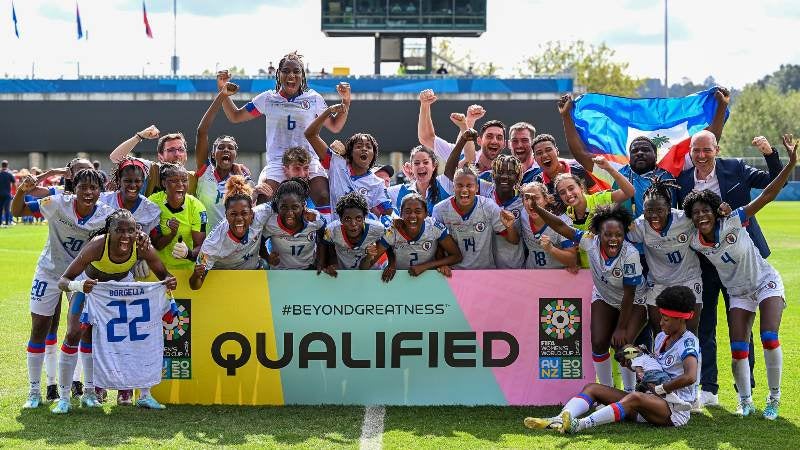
572,87,728,176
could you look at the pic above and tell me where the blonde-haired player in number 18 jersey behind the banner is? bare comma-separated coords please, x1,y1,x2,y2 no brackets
520,178,578,271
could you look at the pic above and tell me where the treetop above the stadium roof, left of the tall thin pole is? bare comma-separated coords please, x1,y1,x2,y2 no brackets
517,41,643,97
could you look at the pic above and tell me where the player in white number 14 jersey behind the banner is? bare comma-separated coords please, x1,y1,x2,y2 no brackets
433,129,519,269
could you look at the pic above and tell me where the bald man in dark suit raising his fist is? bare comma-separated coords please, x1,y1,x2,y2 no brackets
677,130,783,406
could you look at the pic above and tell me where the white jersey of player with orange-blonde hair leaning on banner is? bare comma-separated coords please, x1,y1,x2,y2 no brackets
196,204,273,270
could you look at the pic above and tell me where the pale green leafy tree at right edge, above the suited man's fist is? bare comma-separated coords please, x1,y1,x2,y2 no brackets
720,83,800,156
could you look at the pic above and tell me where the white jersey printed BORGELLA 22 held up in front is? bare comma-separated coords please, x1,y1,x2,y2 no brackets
86,281,174,389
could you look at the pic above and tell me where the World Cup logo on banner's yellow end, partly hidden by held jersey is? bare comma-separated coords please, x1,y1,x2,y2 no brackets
161,299,192,380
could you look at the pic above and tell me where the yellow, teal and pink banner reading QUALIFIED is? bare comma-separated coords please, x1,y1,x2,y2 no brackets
153,270,595,405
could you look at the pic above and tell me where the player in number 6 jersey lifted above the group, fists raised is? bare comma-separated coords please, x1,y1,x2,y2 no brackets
217,52,350,212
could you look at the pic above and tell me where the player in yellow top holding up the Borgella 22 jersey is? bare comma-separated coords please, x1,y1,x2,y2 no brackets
52,209,177,414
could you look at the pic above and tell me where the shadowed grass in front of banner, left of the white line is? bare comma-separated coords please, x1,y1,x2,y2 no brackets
0,401,364,448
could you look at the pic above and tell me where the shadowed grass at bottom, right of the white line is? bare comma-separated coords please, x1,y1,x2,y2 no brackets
384,406,800,449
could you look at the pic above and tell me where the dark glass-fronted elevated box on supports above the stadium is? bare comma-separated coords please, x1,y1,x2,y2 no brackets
321,0,486,74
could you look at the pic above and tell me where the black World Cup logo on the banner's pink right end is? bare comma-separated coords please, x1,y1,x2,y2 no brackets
539,298,583,379
